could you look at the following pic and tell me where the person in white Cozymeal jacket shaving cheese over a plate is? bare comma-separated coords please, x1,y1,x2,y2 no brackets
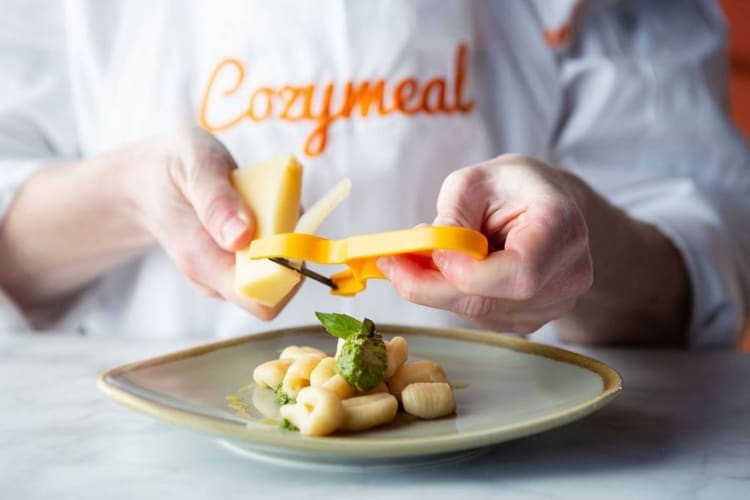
0,0,750,347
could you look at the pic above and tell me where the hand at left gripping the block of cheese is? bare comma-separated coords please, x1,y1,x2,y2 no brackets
121,127,296,320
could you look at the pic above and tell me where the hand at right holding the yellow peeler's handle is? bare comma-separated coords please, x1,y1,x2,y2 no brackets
378,155,593,333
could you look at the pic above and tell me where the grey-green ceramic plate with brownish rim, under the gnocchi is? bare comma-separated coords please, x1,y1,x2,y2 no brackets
99,325,622,466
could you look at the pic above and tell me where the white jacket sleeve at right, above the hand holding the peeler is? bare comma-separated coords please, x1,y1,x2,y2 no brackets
551,0,750,348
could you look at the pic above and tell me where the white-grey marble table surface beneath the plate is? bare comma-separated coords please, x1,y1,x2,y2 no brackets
0,333,750,500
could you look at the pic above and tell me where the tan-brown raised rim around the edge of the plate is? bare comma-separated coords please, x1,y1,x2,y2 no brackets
97,323,623,457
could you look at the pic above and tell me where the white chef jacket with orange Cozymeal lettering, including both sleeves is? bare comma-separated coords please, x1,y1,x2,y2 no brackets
0,0,750,346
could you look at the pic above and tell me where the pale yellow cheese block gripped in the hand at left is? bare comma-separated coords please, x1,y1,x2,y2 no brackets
231,155,302,307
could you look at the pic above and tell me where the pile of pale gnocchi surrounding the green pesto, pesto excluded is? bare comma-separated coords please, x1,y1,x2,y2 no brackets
253,316,456,436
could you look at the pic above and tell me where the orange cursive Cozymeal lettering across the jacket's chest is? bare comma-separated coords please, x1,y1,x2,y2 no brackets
198,44,475,157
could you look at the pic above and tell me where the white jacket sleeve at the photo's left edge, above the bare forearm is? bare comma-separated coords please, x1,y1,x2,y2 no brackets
0,0,77,331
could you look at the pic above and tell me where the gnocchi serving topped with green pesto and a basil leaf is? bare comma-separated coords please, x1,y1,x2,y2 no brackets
253,313,456,436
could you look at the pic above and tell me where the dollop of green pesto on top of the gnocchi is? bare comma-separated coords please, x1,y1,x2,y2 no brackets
336,318,386,392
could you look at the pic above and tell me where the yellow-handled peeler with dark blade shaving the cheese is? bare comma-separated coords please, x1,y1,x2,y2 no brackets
248,226,488,296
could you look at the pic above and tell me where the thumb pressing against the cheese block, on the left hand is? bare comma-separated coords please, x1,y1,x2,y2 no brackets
188,166,254,251
